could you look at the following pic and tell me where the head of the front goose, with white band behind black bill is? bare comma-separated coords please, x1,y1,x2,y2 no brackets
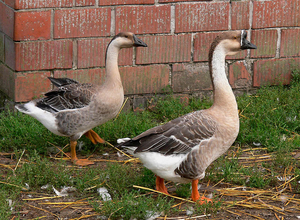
214,30,257,55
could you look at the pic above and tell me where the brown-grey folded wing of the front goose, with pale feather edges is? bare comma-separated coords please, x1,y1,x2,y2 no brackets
121,111,216,155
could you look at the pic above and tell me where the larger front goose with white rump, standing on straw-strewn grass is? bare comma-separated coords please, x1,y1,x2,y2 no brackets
117,30,256,204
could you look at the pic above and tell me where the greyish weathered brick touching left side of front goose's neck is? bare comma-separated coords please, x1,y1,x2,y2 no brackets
172,63,212,92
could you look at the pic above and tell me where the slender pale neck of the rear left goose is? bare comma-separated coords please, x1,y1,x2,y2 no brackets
105,41,122,86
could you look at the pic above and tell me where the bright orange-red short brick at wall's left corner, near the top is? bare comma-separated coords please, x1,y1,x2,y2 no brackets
14,11,51,41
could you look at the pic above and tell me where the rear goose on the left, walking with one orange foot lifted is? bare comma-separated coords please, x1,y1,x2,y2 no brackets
15,32,147,166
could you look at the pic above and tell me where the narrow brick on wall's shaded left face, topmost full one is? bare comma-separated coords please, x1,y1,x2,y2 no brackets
0,2,15,38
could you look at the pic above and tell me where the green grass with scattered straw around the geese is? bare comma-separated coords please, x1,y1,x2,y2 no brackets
0,73,300,219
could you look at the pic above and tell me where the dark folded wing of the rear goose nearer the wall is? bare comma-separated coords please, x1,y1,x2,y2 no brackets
37,78,95,113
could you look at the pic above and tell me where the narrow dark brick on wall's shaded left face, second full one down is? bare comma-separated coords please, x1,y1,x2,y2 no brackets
4,36,16,70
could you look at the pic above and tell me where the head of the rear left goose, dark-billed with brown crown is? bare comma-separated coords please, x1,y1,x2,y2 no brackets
111,32,147,49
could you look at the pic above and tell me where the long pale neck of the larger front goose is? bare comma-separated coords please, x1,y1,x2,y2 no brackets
209,44,237,110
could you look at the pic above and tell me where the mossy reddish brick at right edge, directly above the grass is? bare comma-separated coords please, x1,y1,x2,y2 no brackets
253,58,300,87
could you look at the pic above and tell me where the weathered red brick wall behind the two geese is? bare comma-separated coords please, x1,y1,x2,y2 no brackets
0,0,300,106
